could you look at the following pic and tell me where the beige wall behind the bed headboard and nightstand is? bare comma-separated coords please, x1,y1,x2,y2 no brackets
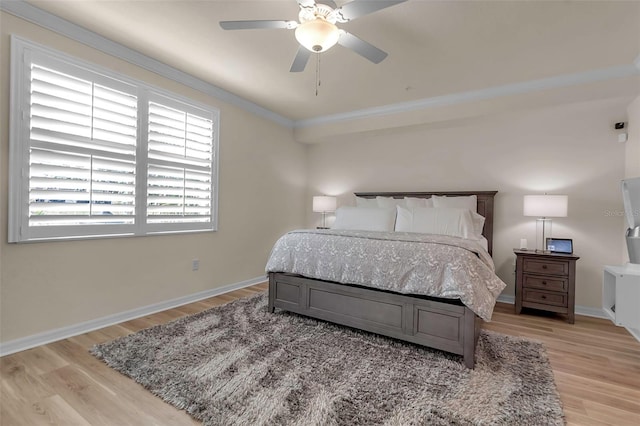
307,99,630,308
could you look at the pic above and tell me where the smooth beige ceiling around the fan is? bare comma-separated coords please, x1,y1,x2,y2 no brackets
11,0,640,123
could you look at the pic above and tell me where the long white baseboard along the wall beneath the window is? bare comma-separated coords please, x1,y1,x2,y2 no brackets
0,276,267,356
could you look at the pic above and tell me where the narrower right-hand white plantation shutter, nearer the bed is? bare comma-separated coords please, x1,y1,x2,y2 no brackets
146,99,214,223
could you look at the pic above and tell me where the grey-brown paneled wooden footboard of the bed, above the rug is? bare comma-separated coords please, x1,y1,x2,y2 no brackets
269,272,482,368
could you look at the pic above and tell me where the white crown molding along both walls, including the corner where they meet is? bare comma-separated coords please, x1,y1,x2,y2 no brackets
0,0,640,133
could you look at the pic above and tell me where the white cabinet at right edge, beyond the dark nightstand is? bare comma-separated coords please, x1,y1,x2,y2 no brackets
602,265,640,340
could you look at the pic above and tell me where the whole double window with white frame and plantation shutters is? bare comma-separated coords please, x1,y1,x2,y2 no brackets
9,36,219,242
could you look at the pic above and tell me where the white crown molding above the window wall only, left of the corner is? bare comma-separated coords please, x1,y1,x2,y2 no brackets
0,0,294,128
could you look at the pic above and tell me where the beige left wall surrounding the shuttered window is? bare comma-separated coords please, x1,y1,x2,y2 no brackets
0,13,306,342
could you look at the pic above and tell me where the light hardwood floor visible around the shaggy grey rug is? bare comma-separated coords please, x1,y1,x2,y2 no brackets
0,283,640,426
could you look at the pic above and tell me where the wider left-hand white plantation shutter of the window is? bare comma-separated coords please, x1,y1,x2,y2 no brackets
29,63,137,226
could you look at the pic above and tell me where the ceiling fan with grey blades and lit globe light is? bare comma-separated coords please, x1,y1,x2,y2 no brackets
220,0,407,72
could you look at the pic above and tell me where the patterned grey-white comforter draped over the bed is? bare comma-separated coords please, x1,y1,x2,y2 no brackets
266,229,506,321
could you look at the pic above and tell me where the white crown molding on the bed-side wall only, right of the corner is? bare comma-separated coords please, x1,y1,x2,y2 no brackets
294,63,640,129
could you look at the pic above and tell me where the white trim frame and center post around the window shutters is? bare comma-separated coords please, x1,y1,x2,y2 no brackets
8,35,220,242
